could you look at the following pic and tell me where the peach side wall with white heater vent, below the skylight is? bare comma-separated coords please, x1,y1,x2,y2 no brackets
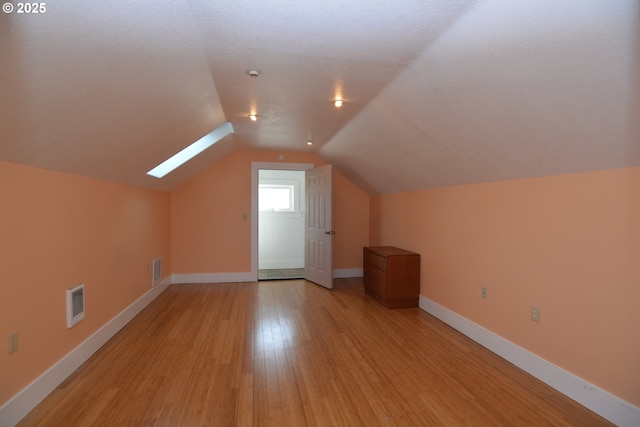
0,161,170,406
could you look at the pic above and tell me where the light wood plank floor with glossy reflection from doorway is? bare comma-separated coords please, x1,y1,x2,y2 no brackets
19,279,610,427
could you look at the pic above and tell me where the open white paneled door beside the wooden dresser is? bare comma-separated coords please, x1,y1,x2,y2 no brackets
304,165,334,289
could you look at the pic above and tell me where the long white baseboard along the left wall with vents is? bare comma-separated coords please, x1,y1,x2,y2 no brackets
0,277,171,427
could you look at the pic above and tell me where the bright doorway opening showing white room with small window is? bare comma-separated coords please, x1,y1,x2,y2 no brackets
258,169,305,280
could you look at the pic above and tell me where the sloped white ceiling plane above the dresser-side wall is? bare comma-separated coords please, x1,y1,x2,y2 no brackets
321,1,640,192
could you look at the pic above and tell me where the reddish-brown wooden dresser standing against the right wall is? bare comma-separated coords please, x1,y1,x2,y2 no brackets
364,246,420,308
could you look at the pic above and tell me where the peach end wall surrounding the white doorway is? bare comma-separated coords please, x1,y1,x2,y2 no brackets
171,150,369,274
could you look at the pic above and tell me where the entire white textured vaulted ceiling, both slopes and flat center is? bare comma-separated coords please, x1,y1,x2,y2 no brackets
0,0,640,193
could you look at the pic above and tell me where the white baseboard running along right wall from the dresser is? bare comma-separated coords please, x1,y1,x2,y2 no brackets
419,295,640,427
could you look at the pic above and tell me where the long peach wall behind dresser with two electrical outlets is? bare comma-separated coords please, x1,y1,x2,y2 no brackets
371,168,640,405
